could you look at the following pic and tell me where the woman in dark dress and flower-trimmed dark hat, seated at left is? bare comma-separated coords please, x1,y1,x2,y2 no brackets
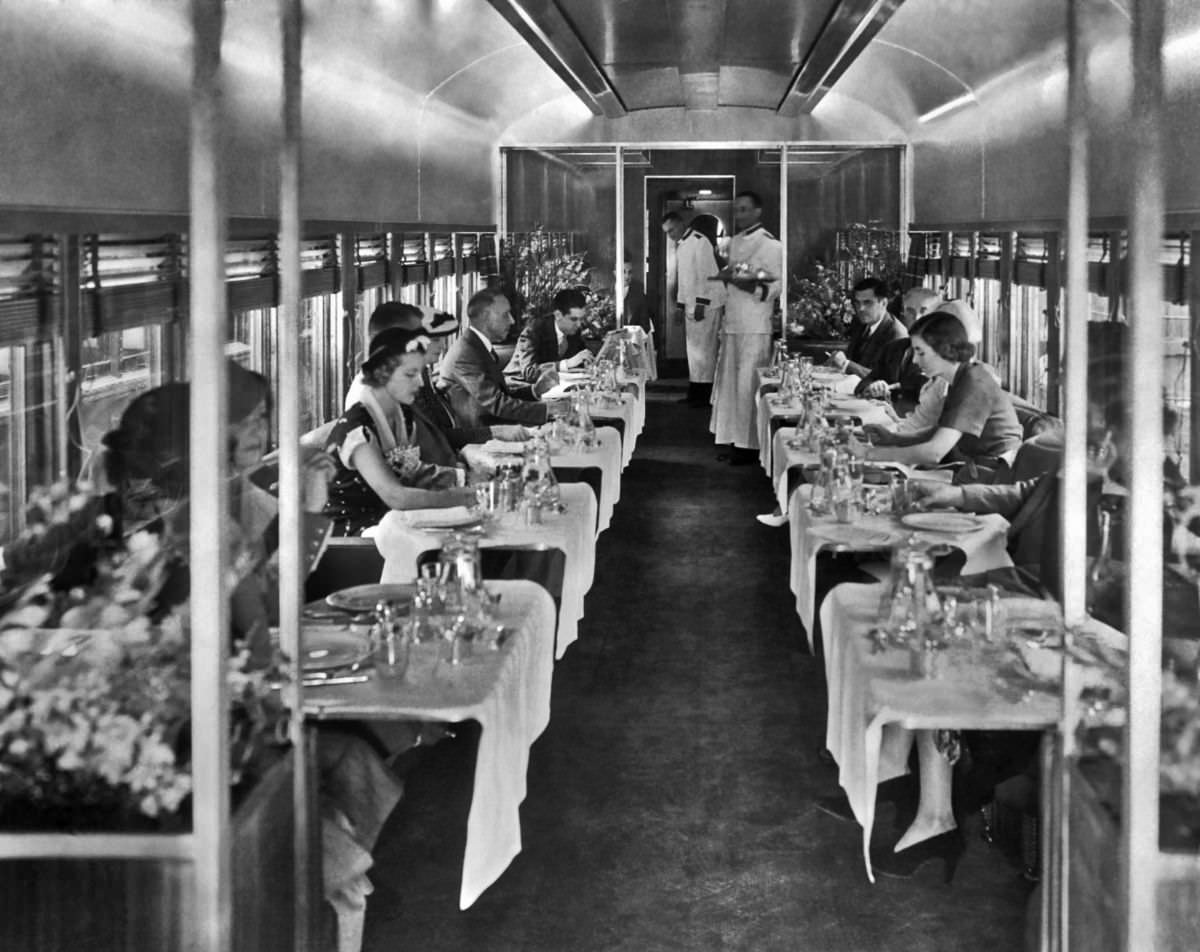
325,328,474,535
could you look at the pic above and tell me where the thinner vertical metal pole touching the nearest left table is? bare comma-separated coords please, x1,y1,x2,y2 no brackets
276,0,316,950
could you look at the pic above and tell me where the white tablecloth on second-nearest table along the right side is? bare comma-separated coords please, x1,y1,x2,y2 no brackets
787,485,1013,648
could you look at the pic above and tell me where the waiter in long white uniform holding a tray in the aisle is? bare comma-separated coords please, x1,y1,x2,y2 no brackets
709,191,784,466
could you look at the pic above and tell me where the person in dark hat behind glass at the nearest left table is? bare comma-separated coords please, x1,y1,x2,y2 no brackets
97,363,420,936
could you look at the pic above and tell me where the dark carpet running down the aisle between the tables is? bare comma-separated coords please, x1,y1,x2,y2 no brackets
365,384,1030,952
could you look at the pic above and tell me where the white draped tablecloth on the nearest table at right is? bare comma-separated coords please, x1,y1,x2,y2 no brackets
821,585,1061,882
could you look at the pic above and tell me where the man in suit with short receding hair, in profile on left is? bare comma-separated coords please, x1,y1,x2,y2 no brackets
442,288,558,426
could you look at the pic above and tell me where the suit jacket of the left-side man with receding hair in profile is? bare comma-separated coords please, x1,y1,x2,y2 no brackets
442,330,548,426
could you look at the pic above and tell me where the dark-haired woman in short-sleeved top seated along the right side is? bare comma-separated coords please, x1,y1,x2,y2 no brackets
870,311,1021,467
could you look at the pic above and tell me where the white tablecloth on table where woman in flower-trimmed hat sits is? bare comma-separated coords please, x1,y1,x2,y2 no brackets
371,483,596,658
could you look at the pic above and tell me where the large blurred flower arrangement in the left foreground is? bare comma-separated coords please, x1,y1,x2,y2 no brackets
0,486,282,830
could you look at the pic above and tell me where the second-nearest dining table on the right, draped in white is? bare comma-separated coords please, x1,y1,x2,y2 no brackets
787,484,1013,649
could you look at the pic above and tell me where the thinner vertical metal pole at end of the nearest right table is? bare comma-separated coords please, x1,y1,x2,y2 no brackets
1060,0,1091,950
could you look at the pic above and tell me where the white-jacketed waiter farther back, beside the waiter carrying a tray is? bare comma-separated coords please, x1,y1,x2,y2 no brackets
662,211,725,407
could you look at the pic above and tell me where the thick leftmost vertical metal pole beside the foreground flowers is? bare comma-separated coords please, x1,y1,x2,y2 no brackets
188,0,233,952
